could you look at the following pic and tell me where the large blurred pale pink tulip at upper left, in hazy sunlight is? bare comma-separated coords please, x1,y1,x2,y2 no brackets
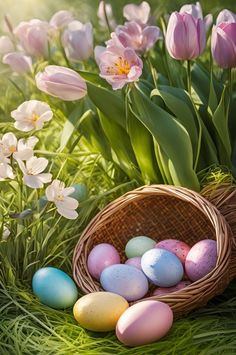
14,19,49,57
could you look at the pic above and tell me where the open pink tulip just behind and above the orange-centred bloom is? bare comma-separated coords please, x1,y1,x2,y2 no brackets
116,21,162,54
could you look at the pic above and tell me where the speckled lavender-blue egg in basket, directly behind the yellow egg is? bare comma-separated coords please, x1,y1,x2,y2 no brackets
100,264,148,301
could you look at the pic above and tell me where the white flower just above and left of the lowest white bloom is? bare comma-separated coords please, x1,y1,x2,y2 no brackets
17,157,52,189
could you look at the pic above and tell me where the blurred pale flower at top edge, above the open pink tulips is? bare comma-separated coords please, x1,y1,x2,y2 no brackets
123,1,150,25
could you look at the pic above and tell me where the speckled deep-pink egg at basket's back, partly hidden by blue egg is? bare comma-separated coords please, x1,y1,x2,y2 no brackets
155,239,191,264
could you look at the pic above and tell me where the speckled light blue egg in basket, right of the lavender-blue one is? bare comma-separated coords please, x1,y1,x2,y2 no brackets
141,248,184,287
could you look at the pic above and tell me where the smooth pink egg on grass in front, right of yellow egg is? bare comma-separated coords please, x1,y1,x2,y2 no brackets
116,300,173,346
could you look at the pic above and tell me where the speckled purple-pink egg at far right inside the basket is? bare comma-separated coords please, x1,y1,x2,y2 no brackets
185,239,217,281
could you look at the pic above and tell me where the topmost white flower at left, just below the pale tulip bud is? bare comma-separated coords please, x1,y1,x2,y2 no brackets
11,100,53,132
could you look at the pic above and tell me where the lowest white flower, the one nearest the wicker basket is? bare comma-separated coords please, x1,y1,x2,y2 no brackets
46,180,79,219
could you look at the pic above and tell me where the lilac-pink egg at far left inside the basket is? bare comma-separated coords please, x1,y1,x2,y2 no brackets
87,243,120,280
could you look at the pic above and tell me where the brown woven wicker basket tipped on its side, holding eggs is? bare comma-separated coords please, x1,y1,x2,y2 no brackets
73,184,236,318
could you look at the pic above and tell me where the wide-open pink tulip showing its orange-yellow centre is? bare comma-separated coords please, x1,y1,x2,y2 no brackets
97,33,143,90
